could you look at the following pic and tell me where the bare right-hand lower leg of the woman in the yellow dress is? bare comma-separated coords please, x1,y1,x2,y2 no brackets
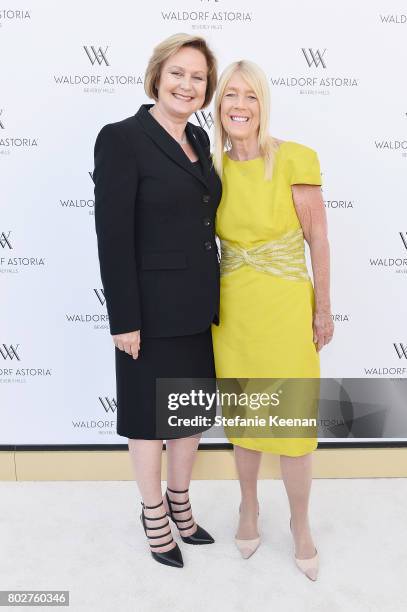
280,453,315,559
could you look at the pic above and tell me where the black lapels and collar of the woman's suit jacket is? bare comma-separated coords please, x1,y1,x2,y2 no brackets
135,104,209,188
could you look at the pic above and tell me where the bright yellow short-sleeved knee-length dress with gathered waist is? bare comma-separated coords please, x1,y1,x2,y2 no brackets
212,141,322,456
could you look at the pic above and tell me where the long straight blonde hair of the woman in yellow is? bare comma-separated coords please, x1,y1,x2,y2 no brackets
213,60,280,180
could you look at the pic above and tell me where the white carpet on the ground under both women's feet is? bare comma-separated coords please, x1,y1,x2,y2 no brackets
0,479,407,612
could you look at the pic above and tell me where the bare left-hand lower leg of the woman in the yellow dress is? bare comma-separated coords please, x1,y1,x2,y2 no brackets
234,446,261,540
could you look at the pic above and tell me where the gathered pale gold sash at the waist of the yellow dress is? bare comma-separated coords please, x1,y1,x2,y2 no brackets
220,229,309,280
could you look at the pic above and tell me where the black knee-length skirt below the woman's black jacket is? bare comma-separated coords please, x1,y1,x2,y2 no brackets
115,327,216,440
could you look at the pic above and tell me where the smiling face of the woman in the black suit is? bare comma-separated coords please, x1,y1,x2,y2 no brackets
157,47,208,118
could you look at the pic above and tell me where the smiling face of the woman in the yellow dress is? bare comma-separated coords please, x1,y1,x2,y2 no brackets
220,71,260,140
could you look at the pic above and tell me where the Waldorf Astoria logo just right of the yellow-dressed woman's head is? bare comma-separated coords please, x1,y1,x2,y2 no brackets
270,47,359,95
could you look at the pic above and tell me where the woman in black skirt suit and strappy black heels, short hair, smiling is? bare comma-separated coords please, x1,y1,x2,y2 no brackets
93,34,221,567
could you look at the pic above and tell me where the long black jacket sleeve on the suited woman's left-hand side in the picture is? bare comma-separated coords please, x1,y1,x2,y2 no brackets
93,124,141,335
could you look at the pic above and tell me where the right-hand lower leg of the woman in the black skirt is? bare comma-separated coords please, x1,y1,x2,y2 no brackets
164,434,201,537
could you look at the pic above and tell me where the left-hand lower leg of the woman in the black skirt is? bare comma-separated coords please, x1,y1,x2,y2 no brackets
129,438,175,552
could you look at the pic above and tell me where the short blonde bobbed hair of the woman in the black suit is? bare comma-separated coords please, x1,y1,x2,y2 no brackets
144,34,218,108
